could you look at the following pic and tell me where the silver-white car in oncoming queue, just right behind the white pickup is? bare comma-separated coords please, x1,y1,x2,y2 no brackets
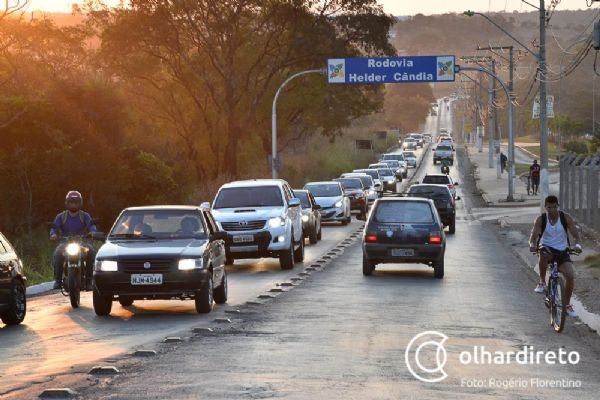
303,181,352,225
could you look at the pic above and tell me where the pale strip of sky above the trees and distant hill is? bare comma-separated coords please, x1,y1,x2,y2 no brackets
23,0,600,15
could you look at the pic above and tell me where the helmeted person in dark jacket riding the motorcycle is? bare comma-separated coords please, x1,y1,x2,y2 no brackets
50,190,96,290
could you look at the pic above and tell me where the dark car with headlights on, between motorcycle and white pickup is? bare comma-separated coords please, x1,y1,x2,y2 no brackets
93,206,227,315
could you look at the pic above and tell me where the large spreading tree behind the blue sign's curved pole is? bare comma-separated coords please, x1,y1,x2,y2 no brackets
85,0,393,180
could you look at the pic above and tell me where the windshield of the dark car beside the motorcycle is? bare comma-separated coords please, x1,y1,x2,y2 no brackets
109,209,206,239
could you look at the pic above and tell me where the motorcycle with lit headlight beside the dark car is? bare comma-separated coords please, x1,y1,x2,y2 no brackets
60,235,90,308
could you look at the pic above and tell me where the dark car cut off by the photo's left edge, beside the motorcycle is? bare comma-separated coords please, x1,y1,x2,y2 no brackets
0,233,27,325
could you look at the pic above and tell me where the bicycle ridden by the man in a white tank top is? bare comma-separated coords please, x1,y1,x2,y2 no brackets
537,246,579,333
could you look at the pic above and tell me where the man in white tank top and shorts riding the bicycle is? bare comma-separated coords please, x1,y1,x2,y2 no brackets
529,195,583,317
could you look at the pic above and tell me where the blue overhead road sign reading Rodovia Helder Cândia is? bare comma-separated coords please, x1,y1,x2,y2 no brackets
327,56,455,85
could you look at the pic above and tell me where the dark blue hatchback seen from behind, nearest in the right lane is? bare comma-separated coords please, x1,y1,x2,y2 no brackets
362,197,446,278
